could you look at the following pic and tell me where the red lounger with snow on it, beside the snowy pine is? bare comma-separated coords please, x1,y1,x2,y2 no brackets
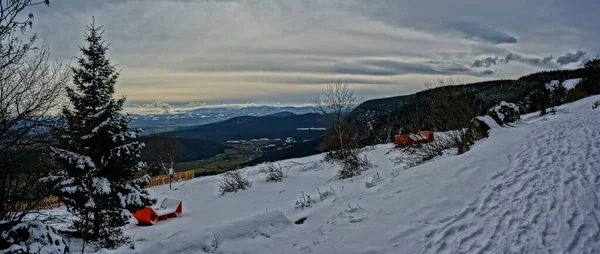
132,198,183,225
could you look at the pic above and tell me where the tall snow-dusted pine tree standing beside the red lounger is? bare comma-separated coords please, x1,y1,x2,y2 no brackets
49,20,155,247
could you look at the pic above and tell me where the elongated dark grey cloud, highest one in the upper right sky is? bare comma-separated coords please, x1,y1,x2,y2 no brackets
450,22,517,44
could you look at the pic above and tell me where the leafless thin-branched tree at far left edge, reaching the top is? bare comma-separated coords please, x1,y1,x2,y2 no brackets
0,0,62,222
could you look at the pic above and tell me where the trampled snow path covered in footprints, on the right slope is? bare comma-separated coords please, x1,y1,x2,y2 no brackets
422,100,600,253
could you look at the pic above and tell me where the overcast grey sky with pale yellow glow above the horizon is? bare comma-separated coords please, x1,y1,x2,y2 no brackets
33,0,600,104
